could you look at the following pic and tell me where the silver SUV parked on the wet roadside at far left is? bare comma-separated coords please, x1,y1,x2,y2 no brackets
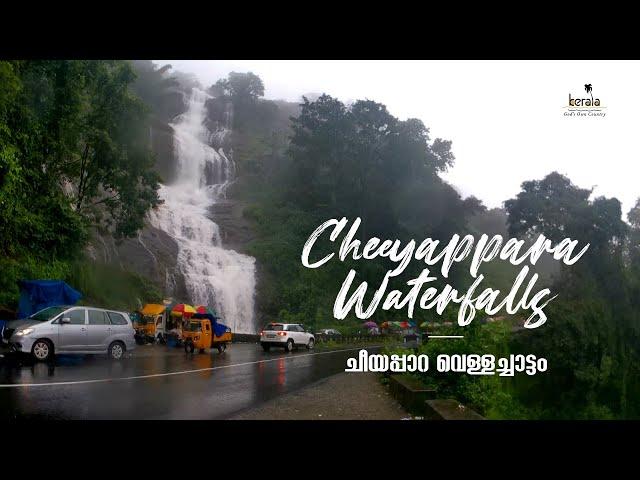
2,306,136,361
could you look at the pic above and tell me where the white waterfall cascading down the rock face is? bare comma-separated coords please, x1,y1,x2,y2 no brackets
150,88,256,333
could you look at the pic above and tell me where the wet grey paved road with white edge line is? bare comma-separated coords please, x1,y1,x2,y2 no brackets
0,344,378,420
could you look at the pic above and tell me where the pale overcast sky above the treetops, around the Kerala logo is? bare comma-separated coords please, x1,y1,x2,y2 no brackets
157,60,640,218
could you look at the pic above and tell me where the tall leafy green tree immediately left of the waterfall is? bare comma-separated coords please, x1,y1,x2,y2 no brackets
64,62,159,238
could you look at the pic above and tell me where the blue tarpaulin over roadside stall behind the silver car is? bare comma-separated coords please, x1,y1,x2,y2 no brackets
18,280,82,318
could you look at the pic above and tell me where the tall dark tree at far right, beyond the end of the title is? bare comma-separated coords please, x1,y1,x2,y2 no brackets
505,172,640,418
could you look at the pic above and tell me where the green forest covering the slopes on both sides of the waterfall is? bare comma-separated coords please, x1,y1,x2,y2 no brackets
0,60,640,419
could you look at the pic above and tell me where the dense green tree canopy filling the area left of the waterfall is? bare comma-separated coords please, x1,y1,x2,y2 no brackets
0,60,159,308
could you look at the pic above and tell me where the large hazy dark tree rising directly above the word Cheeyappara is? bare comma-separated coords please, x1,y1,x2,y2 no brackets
289,94,468,236
